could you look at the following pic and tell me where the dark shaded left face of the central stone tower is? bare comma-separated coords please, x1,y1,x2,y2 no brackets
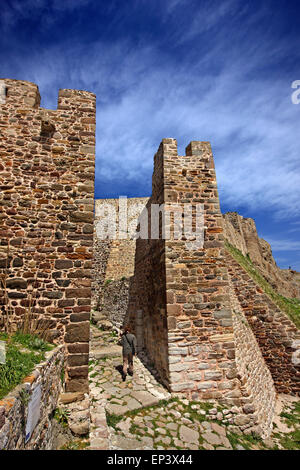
127,146,170,382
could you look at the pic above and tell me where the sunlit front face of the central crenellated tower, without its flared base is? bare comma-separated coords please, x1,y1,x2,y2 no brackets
160,141,240,398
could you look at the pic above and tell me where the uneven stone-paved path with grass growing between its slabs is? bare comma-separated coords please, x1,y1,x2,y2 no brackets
89,327,299,450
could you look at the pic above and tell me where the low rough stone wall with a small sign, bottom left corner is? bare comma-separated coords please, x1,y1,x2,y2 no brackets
0,345,65,450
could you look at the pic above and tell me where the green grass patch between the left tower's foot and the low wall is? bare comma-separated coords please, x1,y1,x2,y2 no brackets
0,332,53,399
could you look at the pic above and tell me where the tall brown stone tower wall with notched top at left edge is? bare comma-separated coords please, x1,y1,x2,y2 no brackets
0,79,96,391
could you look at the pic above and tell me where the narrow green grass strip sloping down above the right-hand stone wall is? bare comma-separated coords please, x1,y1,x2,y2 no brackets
225,240,300,328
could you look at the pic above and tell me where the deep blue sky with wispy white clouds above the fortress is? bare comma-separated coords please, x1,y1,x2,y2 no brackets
0,0,300,271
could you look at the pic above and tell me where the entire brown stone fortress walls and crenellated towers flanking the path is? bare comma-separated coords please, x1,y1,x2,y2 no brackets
0,79,299,436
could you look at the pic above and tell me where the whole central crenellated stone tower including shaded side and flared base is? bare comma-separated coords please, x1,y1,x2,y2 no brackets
128,139,275,435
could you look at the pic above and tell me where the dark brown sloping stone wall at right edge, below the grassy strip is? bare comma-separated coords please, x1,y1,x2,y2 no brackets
226,253,300,395
